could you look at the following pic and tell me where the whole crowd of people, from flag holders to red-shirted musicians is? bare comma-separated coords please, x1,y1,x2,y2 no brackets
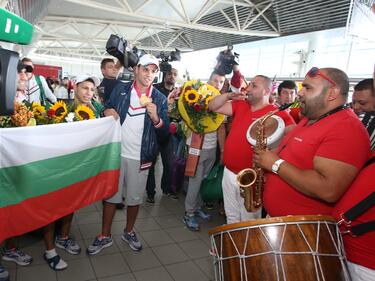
0,51,375,281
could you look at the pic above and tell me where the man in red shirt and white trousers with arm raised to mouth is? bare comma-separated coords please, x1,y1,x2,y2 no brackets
209,75,295,223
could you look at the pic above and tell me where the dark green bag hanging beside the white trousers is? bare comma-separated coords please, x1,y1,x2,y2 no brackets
200,162,224,202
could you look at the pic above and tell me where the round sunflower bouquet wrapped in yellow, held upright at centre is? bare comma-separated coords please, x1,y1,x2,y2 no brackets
178,80,224,134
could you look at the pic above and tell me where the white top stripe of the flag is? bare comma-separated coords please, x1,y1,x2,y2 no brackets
0,117,121,169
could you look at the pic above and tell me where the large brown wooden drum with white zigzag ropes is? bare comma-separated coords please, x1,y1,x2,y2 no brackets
209,216,350,281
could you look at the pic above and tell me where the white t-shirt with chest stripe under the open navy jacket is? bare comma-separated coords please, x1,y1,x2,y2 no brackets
121,87,152,160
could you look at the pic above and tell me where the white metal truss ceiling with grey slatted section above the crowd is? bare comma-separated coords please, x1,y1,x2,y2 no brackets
9,0,350,60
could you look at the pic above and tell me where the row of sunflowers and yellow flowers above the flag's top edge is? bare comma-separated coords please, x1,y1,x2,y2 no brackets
0,101,95,128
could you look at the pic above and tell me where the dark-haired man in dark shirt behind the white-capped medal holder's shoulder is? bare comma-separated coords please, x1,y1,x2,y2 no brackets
99,58,121,103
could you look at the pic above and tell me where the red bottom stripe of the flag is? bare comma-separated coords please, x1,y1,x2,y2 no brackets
0,170,120,242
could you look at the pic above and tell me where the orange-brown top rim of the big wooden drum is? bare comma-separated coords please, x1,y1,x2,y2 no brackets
208,215,336,235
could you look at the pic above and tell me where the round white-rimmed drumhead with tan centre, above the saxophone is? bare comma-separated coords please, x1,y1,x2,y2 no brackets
246,115,285,147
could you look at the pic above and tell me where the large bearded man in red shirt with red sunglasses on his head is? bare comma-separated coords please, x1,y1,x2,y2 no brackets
254,67,370,216
